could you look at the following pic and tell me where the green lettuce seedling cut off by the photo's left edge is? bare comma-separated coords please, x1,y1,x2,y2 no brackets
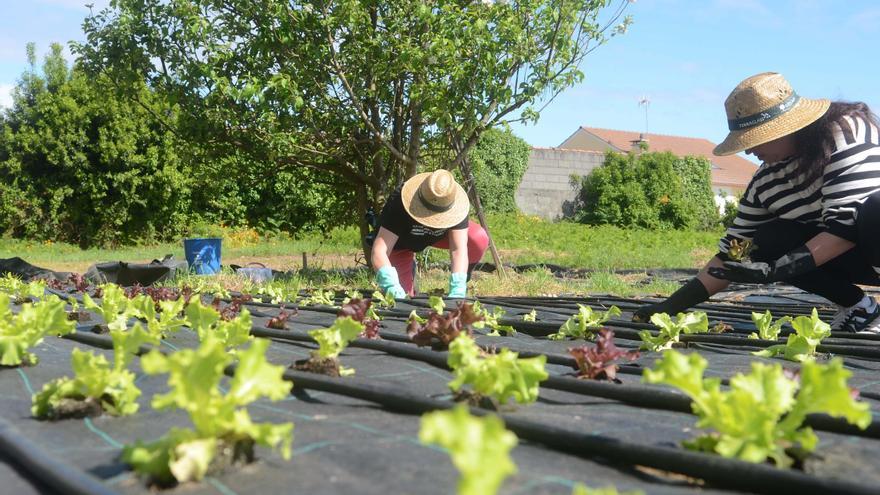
0,292,76,366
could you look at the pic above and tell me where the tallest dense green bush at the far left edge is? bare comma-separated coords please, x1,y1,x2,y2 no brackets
0,44,193,246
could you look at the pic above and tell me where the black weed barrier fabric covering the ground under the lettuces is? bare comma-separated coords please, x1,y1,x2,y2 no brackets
0,289,880,495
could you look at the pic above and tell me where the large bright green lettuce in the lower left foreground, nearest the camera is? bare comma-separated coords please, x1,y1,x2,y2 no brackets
122,338,293,484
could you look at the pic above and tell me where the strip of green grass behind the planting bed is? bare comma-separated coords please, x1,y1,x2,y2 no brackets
0,215,721,295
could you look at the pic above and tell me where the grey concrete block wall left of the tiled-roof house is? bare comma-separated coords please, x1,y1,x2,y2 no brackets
516,148,605,220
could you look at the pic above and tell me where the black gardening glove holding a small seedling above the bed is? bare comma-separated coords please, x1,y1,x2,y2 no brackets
709,245,816,284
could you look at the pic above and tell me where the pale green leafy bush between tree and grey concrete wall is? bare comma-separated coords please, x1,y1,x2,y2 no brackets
470,129,531,213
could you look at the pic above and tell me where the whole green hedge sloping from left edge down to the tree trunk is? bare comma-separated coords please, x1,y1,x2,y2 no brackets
0,44,355,247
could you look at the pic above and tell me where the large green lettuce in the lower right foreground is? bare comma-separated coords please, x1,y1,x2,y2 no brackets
643,351,871,467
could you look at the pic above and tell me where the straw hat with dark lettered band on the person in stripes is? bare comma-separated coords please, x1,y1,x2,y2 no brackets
712,72,831,155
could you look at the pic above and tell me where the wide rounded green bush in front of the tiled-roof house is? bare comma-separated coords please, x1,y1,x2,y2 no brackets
573,152,718,230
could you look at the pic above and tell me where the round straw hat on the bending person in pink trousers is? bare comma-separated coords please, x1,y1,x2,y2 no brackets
400,170,471,229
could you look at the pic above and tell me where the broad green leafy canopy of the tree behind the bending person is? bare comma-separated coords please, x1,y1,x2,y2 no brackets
75,0,629,248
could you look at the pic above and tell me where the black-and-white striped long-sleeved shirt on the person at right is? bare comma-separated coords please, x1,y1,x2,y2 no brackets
718,116,880,253
